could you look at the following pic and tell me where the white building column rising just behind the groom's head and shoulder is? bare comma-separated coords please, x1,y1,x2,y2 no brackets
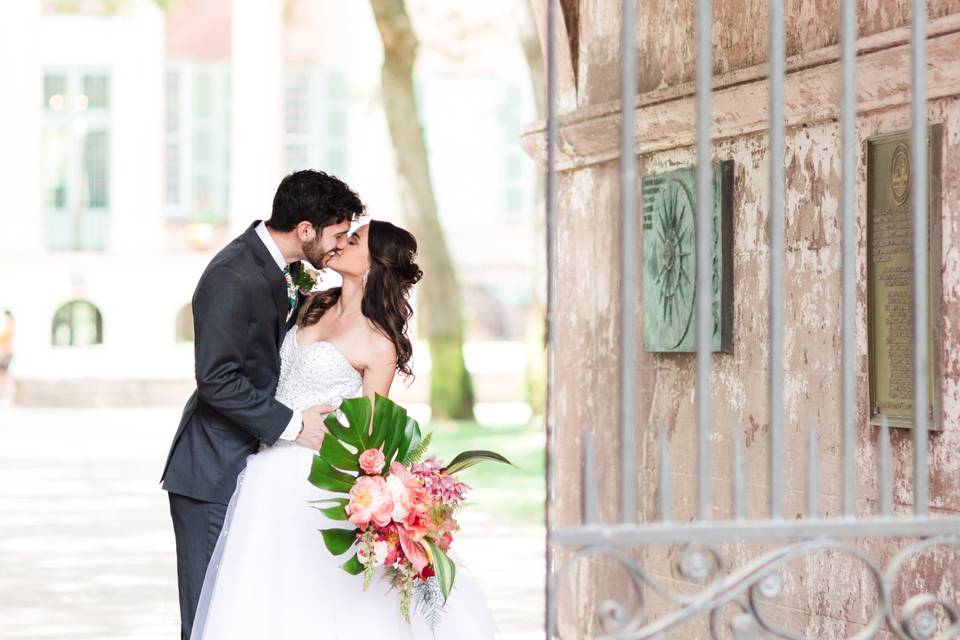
230,0,283,234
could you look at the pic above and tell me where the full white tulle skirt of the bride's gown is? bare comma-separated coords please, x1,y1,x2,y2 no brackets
192,443,496,640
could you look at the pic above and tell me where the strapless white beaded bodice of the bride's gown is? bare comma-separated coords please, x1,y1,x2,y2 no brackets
276,326,363,410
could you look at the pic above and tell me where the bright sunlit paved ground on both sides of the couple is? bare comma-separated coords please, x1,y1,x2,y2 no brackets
0,407,543,640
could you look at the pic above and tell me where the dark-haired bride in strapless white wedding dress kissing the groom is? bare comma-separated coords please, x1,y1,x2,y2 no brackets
191,221,496,640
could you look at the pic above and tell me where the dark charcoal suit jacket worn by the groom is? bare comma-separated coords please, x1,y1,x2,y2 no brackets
161,223,300,504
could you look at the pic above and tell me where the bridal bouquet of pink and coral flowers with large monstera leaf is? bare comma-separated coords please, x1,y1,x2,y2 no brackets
310,395,510,623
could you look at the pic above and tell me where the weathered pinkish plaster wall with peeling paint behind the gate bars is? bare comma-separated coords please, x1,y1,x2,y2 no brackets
551,0,960,638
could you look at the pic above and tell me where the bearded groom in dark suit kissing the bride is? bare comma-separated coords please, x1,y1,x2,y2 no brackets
161,171,364,639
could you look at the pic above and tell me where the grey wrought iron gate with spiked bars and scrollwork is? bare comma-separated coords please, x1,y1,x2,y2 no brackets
547,0,960,639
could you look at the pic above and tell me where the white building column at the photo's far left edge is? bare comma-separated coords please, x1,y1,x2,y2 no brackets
0,0,45,263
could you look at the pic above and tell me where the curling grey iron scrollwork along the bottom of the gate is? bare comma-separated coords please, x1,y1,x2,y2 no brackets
550,535,960,640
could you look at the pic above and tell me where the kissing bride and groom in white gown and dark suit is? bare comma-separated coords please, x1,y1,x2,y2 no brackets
161,170,496,640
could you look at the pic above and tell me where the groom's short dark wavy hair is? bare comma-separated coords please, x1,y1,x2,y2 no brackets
267,169,364,231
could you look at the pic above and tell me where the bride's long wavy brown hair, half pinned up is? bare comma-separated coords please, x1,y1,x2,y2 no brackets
298,220,423,376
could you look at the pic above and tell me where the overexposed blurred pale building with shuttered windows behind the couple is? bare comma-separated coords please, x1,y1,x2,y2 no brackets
0,0,536,410
